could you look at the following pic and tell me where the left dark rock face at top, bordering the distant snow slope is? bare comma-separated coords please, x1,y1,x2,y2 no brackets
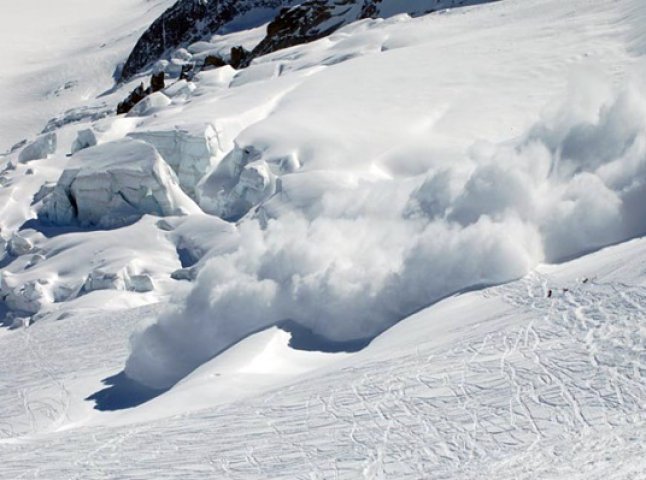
121,0,296,80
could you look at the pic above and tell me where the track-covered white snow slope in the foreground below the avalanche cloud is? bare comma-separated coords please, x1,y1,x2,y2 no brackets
0,235,646,479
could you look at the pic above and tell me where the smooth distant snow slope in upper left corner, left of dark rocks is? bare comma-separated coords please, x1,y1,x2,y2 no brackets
0,0,173,152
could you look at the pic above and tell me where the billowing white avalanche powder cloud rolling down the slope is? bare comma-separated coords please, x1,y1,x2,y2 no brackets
126,76,646,388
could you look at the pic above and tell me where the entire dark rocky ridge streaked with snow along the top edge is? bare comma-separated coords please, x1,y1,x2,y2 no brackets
121,0,496,80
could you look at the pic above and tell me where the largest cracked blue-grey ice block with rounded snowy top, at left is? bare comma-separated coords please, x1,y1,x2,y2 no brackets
39,139,198,228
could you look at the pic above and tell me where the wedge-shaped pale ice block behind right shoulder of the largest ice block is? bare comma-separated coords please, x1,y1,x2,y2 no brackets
129,125,220,198
